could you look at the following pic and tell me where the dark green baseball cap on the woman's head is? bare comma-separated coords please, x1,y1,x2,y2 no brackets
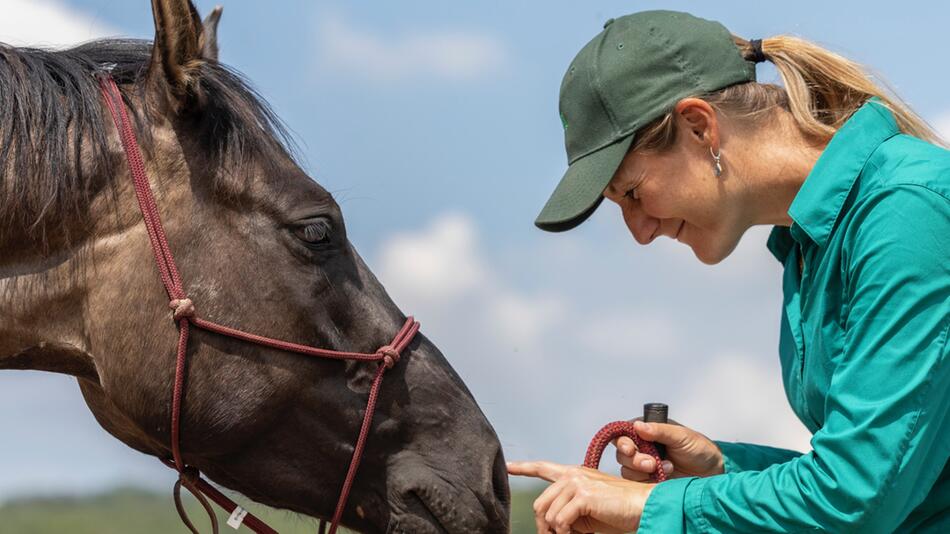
534,11,755,232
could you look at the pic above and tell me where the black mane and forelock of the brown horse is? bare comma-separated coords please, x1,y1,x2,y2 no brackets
0,39,296,243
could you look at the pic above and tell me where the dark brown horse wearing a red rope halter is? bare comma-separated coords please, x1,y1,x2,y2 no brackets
0,0,510,533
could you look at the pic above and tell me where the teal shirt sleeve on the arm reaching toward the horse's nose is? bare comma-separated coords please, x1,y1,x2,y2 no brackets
639,185,950,534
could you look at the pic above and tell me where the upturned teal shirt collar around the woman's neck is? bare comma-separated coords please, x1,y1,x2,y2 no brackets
784,97,900,251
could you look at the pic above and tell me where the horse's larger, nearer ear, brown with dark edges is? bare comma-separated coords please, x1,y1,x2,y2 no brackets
148,0,204,108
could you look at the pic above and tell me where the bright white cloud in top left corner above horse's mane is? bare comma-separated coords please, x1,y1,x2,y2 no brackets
0,0,120,47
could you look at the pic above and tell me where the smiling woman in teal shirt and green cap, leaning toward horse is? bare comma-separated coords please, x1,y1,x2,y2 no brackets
509,11,950,533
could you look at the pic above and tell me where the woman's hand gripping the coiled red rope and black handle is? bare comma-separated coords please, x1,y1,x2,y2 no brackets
614,418,723,482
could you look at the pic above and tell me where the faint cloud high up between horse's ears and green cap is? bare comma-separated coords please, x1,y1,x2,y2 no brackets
317,15,504,82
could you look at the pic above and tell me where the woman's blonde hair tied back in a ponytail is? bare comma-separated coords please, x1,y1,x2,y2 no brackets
631,35,947,151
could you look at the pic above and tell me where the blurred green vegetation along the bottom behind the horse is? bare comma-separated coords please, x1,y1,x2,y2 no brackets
0,488,543,534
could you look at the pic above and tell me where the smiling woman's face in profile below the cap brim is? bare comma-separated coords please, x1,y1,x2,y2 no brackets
604,106,748,265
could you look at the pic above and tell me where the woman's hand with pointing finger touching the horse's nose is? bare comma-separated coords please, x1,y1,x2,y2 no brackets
508,462,654,534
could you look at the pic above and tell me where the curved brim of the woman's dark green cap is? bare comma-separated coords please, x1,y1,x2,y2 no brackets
534,134,633,232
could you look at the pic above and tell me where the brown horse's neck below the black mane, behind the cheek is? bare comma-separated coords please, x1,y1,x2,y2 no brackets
0,149,140,380
